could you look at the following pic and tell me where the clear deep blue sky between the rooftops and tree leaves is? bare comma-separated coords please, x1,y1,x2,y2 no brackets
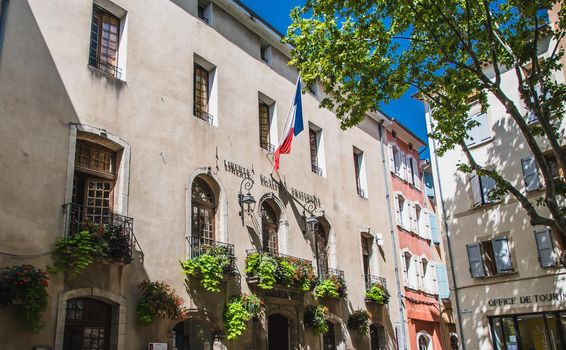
241,0,429,158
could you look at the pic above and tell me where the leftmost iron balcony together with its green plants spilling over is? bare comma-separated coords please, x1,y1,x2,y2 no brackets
50,203,143,276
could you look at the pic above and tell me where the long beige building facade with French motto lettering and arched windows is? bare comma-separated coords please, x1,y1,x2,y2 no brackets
0,0,422,350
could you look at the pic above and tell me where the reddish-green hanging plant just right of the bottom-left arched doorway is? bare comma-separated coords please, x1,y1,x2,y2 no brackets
136,281,187,326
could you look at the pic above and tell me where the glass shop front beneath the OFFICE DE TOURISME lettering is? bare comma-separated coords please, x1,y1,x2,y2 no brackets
489,311,566,350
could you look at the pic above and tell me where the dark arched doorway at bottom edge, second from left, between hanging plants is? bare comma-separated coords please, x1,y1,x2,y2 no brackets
173,318,214,350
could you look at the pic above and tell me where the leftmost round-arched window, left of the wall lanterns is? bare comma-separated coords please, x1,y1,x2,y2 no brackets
191,177,216,240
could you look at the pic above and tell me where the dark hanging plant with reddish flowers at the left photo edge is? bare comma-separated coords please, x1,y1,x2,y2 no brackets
0,265,49,332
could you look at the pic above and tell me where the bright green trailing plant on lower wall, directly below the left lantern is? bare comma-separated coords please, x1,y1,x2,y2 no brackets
223,294,265,340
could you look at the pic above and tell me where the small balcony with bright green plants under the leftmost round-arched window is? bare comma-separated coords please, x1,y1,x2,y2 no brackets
181,237,239,292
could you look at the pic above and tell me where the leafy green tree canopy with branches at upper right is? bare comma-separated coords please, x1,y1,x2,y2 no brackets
286,0,566,245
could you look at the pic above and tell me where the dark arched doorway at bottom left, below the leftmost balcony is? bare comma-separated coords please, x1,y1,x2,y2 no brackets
63,298,113,350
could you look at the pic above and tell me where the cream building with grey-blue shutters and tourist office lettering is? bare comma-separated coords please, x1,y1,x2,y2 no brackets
425,17,566,350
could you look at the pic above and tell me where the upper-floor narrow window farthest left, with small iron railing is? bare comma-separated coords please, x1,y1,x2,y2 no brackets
89,5,122,79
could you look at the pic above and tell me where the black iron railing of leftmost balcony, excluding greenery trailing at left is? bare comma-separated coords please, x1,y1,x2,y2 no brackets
64,203,143,264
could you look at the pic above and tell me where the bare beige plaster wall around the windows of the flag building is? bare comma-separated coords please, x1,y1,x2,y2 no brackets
0,0,398,350
